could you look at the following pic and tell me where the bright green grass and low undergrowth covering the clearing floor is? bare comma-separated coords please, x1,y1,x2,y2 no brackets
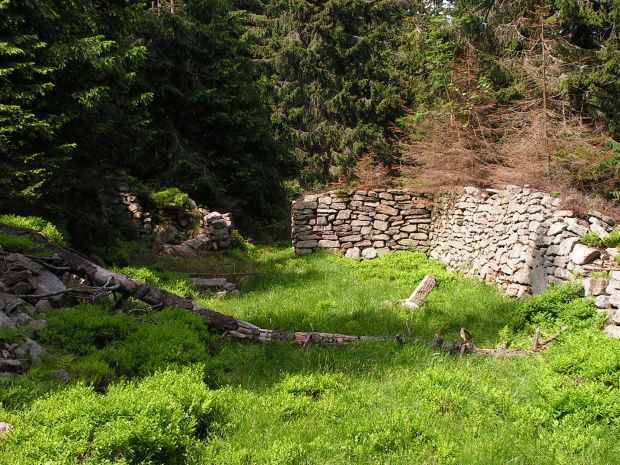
0,249,620,465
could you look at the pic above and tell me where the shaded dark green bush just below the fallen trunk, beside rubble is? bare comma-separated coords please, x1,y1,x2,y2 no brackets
39,304,223,385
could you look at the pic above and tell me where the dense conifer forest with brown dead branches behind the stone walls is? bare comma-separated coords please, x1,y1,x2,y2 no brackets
0,0,620,246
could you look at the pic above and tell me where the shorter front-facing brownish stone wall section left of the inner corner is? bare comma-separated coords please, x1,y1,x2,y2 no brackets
292,189,431,259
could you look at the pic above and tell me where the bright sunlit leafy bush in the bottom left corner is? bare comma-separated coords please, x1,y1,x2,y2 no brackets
0,366,222,465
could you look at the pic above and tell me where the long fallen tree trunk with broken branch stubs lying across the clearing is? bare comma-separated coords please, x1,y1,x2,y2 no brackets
0,223,567,357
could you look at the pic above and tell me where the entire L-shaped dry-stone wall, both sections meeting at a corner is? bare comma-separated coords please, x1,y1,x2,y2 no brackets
292,186,620,337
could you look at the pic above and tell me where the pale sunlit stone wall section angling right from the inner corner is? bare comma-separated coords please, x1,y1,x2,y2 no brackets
429,186,615,297
